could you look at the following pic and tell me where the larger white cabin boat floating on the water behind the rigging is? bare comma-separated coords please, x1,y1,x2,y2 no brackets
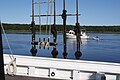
66,30,89,39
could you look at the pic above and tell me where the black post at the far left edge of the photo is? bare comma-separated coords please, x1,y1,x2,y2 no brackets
0,21,5,80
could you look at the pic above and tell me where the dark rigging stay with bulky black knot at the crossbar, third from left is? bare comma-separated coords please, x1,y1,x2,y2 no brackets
62,0,67,59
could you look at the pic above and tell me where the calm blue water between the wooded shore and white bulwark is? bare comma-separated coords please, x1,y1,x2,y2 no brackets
3,33,120,63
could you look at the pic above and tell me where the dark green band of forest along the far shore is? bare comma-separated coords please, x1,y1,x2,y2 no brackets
3,23,120,33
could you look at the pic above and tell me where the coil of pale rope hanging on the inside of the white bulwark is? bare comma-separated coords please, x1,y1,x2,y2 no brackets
7,59,17,76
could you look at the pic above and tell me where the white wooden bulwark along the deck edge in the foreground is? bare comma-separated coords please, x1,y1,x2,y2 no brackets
4,54,120,80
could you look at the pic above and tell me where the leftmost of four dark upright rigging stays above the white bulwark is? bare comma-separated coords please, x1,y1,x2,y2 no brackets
31,0,37,56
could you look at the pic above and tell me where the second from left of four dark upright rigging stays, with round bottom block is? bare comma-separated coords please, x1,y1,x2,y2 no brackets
51,0,58,58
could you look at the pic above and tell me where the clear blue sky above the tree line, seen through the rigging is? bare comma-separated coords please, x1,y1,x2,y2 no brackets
0,0,120,26
